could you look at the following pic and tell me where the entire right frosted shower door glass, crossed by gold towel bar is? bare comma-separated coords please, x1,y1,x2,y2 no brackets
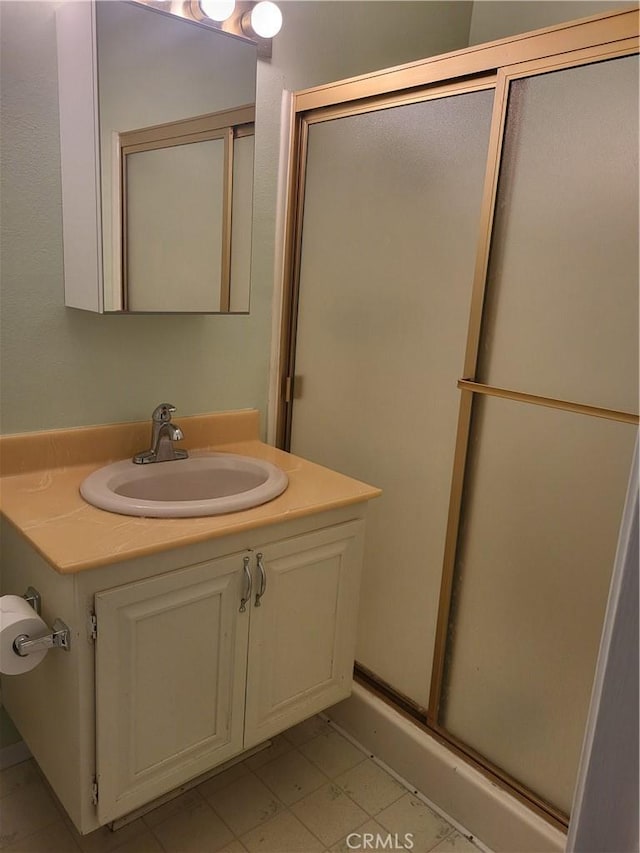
438,57,639,815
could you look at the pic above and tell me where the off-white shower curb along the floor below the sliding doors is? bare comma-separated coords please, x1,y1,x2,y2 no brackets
327,684,567,853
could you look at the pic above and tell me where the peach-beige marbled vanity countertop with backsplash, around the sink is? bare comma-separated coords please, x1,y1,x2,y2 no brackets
0,410,380,574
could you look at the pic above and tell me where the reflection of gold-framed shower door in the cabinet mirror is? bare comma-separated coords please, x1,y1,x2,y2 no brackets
117,106,255,313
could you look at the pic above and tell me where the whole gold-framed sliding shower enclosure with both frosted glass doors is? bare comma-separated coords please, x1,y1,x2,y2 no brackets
279,12,638,826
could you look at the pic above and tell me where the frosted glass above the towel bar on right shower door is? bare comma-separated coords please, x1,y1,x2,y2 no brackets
478,56,639,412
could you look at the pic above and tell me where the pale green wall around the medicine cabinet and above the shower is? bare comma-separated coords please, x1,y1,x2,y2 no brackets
0,0,471,433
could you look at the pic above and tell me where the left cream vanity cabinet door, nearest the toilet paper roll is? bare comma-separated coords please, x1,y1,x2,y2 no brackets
95,553,249,823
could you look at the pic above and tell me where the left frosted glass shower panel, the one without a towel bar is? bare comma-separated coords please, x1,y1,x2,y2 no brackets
290,89,493,707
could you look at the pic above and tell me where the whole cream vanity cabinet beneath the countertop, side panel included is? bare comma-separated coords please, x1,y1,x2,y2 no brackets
3,504,366,833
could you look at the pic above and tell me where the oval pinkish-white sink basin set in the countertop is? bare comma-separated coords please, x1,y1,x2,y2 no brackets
80,453,289,518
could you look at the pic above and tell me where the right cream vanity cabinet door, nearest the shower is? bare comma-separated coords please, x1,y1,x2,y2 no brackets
244,521,364,748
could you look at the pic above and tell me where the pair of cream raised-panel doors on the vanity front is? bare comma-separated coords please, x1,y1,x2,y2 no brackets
95,521,364,823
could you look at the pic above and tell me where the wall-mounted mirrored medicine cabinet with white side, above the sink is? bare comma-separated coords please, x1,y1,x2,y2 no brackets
58,0,257,313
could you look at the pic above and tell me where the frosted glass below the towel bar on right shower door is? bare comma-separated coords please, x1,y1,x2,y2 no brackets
442,397,636,814
